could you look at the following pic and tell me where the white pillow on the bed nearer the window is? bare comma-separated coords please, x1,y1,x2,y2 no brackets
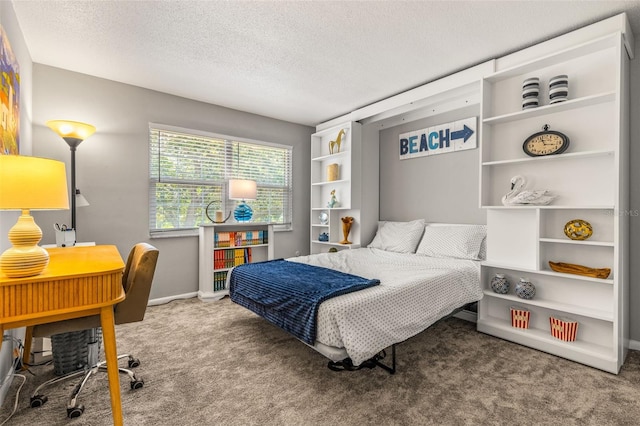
368,219,424,253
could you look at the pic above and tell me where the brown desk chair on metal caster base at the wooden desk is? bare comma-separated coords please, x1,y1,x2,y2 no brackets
23,243,159,418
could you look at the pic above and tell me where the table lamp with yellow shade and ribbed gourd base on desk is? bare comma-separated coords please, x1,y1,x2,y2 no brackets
0,155,69,278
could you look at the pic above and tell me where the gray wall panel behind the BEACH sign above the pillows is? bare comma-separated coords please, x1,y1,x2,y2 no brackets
380,106,486,223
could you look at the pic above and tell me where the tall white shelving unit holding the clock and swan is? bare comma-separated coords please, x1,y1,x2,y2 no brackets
477,32,632,373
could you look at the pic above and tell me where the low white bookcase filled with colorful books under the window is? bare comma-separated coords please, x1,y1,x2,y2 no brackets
198,223,273,301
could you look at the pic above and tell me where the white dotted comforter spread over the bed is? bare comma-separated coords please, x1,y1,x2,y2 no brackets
287,248,482,365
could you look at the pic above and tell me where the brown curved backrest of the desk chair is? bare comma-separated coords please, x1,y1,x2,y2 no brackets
115,243,159,324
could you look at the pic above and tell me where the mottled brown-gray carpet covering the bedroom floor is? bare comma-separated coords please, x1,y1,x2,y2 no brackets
0,298,640,426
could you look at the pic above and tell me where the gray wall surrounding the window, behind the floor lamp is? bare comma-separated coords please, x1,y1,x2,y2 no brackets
33,64,314,299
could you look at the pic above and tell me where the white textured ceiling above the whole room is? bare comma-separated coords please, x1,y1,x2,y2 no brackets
12,0,640,125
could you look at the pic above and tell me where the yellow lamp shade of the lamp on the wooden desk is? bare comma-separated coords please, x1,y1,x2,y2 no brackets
0,155,69,210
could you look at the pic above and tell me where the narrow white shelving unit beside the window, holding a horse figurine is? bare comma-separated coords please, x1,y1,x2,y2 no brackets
310,122,364,254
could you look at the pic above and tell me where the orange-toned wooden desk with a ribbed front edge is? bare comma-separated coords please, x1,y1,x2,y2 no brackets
0,246,125,425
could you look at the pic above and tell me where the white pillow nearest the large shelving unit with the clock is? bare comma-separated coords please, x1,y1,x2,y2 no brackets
416,225,487,260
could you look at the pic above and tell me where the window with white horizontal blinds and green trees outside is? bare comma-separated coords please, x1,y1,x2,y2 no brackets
149,123,293,235
